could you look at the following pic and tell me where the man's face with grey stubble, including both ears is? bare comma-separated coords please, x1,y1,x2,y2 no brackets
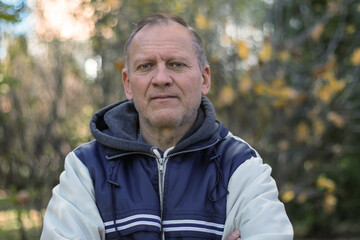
123,22,210,129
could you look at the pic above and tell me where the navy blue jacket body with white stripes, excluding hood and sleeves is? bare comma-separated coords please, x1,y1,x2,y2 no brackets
75,125,256,240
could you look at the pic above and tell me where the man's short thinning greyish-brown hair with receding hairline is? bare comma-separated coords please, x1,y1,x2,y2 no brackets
124,13,208,73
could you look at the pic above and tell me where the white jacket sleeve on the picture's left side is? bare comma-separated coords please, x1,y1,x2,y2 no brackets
40,152,105,240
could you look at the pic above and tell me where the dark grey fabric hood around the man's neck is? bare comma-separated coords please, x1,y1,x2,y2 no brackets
90,97,227,153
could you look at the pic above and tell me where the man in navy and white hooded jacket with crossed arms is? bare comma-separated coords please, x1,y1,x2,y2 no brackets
42,14,293,240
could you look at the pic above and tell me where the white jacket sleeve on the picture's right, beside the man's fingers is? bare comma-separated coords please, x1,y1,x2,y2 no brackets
223,158,293,240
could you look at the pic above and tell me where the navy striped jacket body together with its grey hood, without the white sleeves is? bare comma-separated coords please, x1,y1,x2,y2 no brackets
81,97,256,240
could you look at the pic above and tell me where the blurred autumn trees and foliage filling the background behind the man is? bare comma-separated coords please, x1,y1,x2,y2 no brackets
0,0,360,240
